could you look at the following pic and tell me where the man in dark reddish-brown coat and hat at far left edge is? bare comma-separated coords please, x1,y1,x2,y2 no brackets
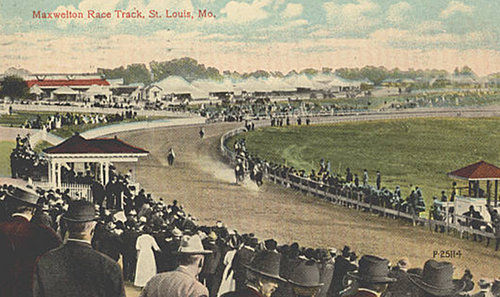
0,187,61,297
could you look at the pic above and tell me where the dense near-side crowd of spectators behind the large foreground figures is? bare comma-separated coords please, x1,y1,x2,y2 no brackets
0,169,500,297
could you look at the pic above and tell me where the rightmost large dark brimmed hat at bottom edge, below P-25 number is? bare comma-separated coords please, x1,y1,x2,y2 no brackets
408,260,465,296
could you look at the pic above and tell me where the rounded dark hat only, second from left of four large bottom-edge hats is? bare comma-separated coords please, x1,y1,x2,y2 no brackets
288,260,323,288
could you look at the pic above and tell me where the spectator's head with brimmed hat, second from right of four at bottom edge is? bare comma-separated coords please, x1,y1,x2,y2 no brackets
347,255,396,297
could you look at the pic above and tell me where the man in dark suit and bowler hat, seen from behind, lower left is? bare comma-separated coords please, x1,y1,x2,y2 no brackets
33,200,125,297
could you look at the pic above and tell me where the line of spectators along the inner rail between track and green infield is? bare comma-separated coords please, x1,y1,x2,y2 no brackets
233,138,500,250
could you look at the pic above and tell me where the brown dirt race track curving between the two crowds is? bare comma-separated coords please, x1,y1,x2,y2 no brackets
118,119,500,296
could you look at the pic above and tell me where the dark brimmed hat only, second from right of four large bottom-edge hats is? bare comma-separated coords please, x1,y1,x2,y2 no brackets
347,255,396,284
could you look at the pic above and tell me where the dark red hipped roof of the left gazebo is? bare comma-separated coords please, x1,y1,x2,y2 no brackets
43,134,148,154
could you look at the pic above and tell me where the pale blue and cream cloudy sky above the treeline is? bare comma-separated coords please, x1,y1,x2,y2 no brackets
0,0,500,75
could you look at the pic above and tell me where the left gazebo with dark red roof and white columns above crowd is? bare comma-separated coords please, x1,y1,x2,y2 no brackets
43,133,148,189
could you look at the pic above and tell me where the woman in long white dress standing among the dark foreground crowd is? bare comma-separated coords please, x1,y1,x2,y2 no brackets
134,228,160,287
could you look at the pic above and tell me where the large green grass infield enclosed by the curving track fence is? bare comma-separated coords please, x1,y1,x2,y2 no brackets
229,118,500,202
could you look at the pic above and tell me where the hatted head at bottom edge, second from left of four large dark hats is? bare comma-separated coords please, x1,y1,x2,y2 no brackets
288,260,323,297
